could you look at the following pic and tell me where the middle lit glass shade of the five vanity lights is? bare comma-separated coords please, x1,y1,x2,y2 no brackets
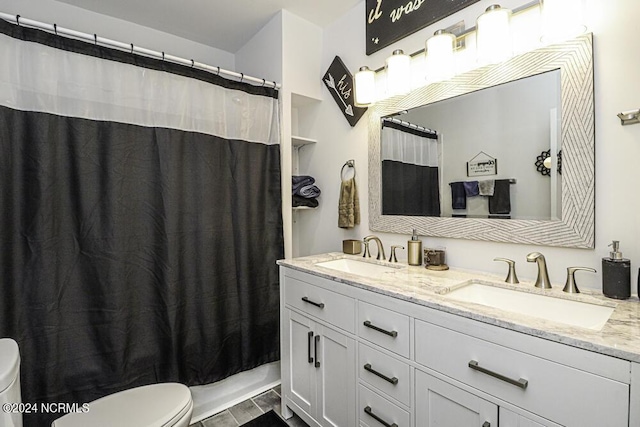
425,30,456,83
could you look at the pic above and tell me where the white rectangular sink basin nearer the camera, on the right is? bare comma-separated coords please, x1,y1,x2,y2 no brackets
446,282,614,331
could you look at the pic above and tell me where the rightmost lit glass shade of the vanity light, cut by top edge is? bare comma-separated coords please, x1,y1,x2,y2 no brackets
540,0,587,44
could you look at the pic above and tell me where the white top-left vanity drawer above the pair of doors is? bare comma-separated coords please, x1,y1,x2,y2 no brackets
284,277,356,333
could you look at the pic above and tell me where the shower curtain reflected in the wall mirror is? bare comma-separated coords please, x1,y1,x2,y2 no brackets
381,120,440,216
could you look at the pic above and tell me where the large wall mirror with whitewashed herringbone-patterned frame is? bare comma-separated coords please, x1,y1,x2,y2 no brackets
369,34,595,248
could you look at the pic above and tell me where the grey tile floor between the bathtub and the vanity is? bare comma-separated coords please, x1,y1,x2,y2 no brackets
190,386,308,427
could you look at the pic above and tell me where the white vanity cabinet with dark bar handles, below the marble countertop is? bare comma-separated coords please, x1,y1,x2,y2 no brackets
280,267,640,427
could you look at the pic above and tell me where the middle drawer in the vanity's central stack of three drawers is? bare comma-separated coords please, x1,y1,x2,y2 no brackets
358,343,411,406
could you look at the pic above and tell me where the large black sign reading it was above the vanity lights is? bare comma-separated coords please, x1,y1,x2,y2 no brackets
365,0,480,55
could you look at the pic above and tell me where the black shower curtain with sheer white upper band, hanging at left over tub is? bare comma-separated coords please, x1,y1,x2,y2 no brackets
0,20,283,426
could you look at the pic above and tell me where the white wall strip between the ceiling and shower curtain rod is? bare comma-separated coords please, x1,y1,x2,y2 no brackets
0,0,235,70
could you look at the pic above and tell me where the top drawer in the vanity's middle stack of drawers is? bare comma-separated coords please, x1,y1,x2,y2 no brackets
358,301,410,358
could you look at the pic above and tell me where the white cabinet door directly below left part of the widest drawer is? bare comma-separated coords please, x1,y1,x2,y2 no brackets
416,371,498,427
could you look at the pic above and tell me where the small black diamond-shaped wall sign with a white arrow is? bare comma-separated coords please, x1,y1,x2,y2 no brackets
322,56,367,126
